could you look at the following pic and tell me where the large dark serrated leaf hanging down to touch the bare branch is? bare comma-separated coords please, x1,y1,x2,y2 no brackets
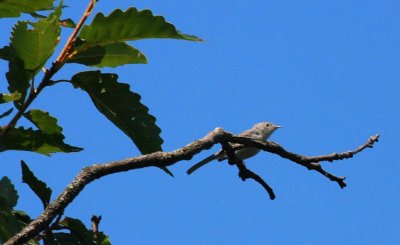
71,71,163,154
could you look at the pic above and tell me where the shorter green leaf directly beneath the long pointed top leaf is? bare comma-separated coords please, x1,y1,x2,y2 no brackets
67,42,147,68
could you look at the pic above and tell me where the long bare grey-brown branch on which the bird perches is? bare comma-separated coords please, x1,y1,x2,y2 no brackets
5,128,379,245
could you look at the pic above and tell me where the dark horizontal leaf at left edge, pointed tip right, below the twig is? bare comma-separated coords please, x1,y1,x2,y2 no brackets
0,127,82,155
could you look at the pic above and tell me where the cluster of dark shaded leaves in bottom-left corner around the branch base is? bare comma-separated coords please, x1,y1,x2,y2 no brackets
0,161,111,245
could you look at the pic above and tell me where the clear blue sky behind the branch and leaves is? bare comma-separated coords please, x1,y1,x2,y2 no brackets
0,0,400,244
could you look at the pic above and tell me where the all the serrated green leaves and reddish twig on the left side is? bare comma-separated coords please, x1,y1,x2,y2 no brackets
0,0,201,244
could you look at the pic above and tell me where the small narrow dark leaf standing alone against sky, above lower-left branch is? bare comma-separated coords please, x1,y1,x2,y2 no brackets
21,161,51,208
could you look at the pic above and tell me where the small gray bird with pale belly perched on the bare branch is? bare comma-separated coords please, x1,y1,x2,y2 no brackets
186,122,281,174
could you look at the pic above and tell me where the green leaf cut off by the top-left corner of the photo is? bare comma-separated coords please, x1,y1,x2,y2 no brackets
0,0,54,18
